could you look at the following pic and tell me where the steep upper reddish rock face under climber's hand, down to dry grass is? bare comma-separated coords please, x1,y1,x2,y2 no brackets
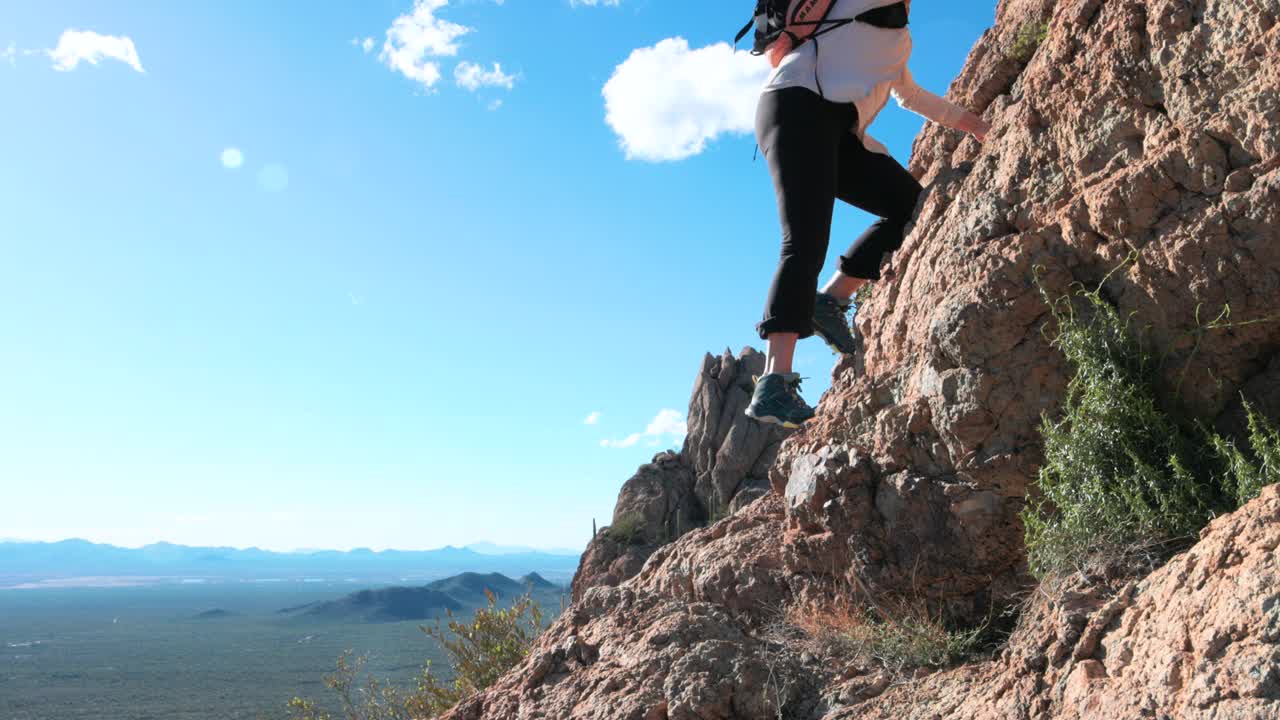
773,0,1280,616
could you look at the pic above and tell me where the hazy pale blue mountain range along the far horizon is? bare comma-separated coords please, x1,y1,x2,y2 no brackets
0,539,577,588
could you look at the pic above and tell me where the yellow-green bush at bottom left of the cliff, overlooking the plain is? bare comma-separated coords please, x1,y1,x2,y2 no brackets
289,589,543,720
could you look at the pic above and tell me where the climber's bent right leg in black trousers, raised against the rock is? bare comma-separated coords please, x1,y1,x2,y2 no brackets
827,133,922,280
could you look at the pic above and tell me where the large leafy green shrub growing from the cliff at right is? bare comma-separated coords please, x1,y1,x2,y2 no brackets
1023,274,1280,577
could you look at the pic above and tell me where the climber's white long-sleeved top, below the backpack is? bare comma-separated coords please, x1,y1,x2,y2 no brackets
764,0,968,155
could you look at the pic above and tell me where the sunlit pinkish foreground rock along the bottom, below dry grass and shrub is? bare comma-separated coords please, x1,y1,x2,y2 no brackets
445,487,1280,720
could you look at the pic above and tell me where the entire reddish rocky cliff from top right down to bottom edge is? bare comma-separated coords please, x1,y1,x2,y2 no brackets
449,0,1280,720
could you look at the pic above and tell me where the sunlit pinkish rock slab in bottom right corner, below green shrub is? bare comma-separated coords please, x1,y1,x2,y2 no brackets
824,487,1280,720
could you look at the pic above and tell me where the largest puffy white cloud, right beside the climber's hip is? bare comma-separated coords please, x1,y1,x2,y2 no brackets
604,37,769,163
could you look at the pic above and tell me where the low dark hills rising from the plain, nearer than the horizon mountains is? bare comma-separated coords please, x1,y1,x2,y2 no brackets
280,573,566,623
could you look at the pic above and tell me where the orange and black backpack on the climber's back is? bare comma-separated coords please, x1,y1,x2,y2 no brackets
733,0,908,67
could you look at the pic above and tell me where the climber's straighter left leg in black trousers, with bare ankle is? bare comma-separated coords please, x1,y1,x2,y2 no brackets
756,87,855,374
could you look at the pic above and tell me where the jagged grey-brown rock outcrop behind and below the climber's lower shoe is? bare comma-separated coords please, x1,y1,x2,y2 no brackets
572,347,787,600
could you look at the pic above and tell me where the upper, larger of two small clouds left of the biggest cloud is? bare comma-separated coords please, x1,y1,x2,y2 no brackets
378,0,471,90
